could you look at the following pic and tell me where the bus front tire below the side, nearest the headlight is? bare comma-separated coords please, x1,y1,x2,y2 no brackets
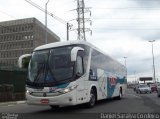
87,88,96,108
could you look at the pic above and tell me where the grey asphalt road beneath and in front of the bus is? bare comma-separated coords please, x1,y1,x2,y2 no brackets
0,89,160,119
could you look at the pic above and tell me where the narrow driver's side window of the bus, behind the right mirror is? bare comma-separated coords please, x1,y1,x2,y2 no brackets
76,56,83,76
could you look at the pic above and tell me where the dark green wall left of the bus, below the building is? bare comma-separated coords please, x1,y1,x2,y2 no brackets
0,70,27,102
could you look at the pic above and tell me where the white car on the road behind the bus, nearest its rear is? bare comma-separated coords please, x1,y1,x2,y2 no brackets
136,84,152,93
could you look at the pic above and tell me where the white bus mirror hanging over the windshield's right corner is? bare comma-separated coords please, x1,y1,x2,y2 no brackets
71,47,84,62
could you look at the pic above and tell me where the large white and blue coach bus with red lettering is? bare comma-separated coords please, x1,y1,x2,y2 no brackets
18,41,127,108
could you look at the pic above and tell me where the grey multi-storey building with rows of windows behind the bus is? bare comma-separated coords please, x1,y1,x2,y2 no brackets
0,18,60,67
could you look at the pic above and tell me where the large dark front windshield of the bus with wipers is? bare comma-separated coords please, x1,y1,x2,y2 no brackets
27,46,74,86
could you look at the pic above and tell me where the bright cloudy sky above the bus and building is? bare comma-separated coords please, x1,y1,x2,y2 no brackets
0,0,160,81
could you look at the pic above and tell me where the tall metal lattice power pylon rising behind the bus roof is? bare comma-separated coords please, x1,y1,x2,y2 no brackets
77,0,91,41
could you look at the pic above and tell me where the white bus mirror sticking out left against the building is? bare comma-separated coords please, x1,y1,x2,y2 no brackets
18,54,31,68
